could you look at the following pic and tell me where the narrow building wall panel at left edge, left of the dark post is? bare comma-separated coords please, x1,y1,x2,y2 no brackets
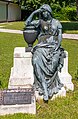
0,1,7,22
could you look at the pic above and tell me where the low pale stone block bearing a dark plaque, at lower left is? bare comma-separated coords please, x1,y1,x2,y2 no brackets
0,88,36,115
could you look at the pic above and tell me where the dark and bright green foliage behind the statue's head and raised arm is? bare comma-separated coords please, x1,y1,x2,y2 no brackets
14,0,77,20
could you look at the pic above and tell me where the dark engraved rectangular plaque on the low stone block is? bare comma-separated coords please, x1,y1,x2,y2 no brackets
0,89,34,105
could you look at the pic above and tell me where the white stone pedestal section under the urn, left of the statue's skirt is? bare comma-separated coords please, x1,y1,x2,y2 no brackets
8,47,34,89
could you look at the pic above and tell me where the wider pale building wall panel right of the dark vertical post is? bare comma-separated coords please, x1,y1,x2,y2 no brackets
8,3,21,21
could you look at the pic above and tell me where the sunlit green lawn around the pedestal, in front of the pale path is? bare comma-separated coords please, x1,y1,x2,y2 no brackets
0,33,78,119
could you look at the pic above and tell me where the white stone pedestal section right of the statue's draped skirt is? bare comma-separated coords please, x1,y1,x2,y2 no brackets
58,51,74,91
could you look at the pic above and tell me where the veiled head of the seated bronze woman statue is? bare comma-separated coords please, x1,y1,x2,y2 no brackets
40,4,52,20
